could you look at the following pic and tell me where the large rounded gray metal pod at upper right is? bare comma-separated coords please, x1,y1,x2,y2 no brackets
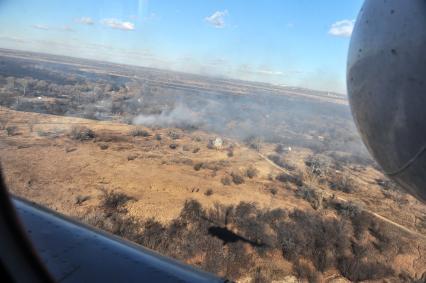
347,0,426,201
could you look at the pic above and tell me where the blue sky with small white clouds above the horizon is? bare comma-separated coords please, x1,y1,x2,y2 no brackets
0,0,363,93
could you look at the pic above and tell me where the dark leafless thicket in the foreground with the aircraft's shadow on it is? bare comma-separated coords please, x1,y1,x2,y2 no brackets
79,192,413,282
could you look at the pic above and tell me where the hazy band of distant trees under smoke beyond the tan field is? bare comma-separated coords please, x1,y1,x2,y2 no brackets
0,58,371,168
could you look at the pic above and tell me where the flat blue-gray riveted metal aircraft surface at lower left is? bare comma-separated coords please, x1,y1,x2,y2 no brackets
13,199,224,282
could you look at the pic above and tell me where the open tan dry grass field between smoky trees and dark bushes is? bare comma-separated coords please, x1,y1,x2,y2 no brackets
0,108,426,280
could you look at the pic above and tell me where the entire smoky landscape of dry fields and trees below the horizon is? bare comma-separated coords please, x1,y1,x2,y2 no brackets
0,50,426,282
